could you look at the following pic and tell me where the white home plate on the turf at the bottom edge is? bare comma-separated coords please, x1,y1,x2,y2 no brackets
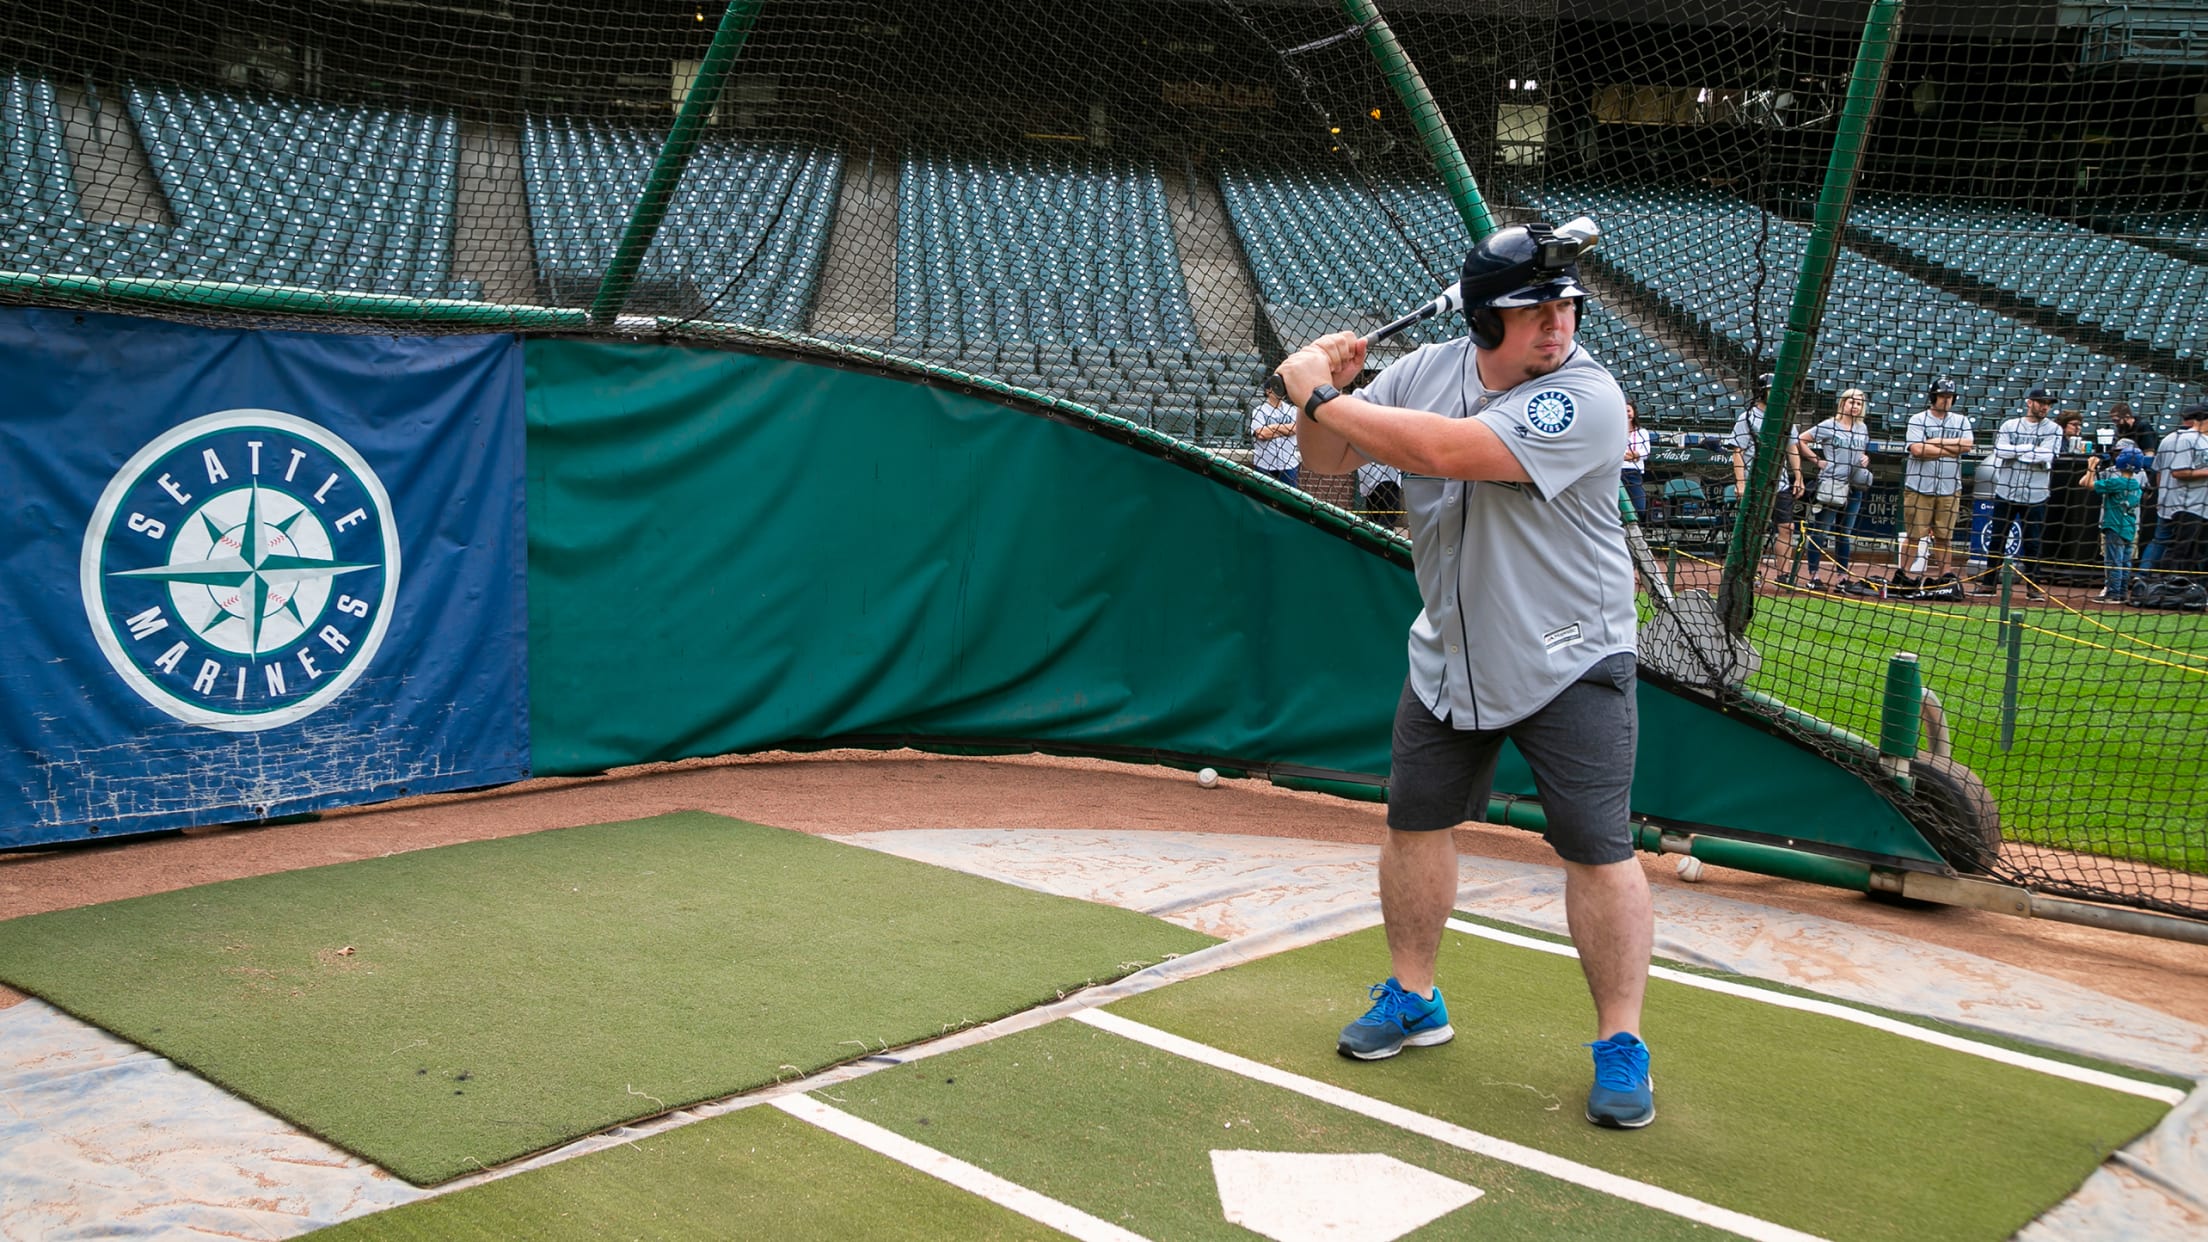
1212,1151,1479,1242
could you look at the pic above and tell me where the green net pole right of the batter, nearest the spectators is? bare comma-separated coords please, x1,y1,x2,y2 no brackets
1718,0,1901,634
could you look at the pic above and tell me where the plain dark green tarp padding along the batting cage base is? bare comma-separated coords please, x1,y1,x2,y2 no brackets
528,340,1936,860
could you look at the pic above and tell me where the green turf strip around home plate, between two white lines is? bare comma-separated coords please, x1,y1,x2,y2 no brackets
815,1021,1711,1242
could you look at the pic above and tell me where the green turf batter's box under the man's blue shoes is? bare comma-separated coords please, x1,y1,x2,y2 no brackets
1113,928,2168,1238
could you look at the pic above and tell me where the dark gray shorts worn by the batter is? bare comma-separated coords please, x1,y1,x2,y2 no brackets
1387,652,1641,864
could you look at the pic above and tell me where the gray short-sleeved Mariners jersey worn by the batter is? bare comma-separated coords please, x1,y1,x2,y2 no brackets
1351,338,1634,729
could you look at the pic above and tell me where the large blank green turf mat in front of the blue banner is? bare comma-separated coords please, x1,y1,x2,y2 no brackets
0,813,1214,1185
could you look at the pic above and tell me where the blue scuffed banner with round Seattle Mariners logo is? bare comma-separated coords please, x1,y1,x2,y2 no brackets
0,309,528,849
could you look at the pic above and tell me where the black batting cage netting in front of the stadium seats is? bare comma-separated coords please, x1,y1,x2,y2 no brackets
0,0,2208,915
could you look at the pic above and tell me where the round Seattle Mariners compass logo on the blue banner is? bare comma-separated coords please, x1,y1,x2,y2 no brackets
79,409,400,731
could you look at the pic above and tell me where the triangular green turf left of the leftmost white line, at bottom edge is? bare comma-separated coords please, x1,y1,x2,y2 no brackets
311,1107,1058,1242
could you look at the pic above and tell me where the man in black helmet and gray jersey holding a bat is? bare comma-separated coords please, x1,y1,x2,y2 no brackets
1281,219,1656,1129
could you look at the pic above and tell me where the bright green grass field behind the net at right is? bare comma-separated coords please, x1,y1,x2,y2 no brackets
1722,597,2208,873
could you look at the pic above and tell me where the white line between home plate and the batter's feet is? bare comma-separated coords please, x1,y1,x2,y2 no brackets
1073,1010,1817,1242
